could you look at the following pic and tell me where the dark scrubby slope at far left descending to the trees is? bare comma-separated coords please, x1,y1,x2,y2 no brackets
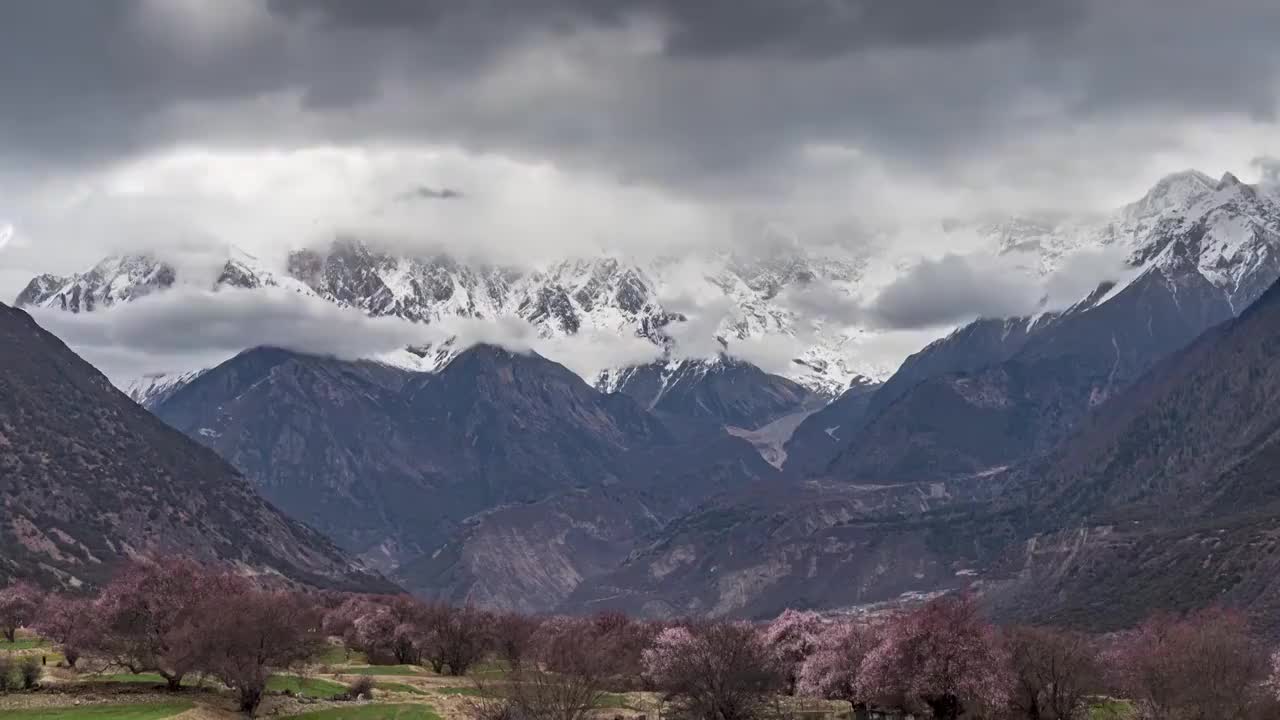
0,299,394,591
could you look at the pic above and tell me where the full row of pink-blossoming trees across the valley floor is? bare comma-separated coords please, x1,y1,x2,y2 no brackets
0,560,1280,720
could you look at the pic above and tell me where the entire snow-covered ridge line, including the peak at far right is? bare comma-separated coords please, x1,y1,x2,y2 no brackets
17,170,1280,397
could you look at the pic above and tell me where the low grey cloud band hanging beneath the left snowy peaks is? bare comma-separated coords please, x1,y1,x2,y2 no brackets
28,283,660,386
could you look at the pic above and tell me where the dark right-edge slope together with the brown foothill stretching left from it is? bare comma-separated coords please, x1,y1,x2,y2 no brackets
568,271,1280,620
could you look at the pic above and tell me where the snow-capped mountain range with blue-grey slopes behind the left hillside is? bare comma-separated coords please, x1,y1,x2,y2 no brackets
12,172,1280,626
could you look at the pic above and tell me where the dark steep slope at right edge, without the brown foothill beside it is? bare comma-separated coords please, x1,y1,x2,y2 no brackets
989,274,1280,629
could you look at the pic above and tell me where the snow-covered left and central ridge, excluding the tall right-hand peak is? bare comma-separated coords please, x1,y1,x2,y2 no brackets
18,241,892,395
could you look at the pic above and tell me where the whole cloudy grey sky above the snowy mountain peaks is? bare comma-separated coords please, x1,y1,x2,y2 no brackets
0,0,1280,381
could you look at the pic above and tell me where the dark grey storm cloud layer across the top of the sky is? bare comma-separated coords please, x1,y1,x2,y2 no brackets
0,0,1280,191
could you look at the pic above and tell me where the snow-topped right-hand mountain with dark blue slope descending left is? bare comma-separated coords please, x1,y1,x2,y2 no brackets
790,173,1280,482
